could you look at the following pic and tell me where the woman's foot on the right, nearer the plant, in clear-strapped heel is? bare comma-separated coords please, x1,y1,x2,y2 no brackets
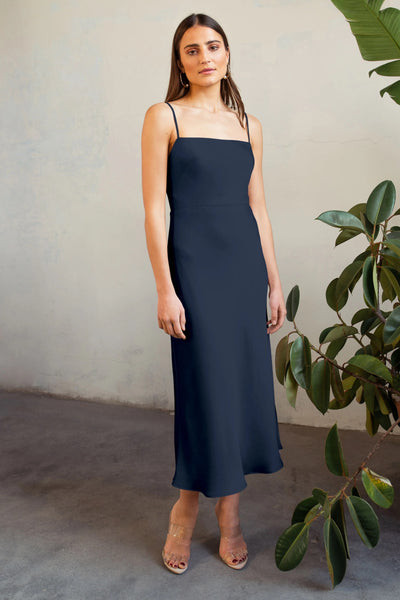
215,497,248,569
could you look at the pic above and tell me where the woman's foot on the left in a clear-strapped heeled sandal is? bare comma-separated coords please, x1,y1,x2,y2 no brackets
162,496,199,574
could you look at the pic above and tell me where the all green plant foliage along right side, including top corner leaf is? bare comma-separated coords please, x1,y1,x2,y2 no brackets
275,0,400,587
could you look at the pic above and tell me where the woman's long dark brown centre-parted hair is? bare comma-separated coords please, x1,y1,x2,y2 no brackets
165,13,244,127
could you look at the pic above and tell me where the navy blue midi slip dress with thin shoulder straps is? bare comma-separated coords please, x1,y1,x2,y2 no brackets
167,102,283,497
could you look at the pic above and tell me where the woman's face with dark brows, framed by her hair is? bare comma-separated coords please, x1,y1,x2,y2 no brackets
178,25,229,86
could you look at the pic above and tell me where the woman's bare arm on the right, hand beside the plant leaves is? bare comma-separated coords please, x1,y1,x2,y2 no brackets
247,115,286,333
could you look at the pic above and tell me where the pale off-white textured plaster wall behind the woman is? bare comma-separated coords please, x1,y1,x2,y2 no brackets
0,0,400,428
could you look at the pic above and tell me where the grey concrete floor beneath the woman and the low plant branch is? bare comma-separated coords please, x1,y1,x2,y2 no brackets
0,391,400,600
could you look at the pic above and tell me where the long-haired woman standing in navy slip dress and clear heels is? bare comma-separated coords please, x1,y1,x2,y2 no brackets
142,14,286,574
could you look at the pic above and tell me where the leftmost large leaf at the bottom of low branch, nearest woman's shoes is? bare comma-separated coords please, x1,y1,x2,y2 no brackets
275,523,310,571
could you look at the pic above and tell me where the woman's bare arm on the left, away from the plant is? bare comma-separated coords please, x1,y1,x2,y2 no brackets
141,102,186,339
